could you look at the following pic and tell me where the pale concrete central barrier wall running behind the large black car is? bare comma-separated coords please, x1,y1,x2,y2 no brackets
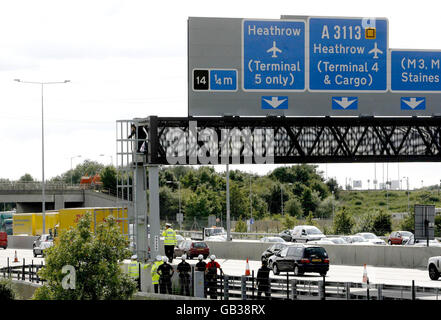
207,241,441,268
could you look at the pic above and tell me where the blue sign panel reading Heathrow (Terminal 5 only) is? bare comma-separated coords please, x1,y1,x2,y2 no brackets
242,20,305,91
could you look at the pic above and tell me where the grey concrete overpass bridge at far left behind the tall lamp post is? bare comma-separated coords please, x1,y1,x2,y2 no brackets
0,182,117,213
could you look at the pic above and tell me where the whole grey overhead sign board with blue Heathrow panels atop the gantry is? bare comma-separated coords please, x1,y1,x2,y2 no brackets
188,15,441,117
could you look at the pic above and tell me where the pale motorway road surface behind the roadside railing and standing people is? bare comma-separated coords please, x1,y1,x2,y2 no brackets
0,249,441,288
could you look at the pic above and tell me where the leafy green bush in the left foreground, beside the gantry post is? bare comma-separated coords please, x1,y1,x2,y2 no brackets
34,213,136,300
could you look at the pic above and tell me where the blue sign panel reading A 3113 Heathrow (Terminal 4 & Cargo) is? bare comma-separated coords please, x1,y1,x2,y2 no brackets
309,18,388,91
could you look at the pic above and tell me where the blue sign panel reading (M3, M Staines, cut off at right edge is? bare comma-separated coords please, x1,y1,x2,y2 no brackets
391,50,441,92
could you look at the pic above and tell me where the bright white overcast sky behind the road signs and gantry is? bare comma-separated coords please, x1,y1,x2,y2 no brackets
0,0,441,188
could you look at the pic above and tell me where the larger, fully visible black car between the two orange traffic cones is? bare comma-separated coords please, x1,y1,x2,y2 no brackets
271,245,329,276
